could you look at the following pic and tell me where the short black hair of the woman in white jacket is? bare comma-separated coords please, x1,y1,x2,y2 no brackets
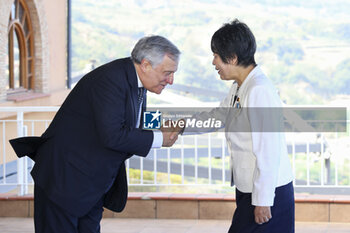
211,19,256,67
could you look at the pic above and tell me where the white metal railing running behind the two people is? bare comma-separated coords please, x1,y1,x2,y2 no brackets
0,107,350,195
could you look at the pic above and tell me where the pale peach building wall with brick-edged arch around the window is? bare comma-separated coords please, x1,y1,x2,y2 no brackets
0,0,67,106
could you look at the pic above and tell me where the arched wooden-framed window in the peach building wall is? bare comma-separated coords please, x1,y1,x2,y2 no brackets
7,0,34,94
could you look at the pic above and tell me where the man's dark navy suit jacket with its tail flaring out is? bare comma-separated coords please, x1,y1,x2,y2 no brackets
12,58,153,216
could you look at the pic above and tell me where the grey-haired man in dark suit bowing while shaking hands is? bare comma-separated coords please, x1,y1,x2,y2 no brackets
11,36,180,233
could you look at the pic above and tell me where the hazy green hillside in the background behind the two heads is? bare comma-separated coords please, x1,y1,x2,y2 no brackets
72,0,350,104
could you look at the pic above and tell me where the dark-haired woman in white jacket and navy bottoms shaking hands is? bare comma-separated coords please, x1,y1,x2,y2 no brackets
180,19,294,233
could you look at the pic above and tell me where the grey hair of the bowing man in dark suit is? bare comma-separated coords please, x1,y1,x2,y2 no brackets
131,36,180,67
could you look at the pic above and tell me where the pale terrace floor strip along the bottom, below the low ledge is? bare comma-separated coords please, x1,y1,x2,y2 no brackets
0,218,350,233
